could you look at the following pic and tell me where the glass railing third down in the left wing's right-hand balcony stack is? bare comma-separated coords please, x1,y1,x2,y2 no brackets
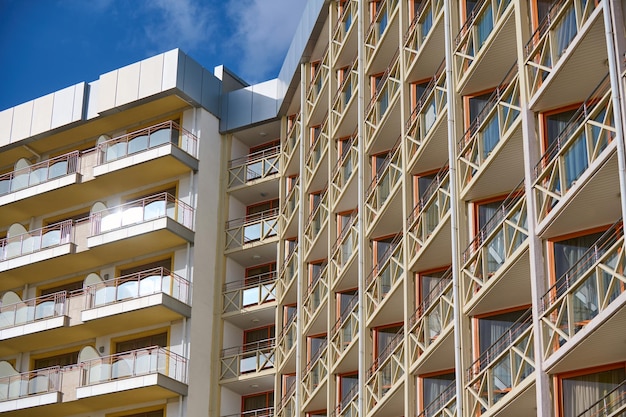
84,267,190,309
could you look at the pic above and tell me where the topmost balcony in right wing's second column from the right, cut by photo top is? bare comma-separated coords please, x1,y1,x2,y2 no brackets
454,0,517,95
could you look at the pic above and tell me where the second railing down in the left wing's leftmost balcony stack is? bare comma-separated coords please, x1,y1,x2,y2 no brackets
0,220,74,261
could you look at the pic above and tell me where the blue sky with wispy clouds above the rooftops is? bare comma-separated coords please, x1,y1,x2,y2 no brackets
0,0,306,110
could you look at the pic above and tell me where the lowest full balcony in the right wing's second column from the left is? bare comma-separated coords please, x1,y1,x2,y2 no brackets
301,341,328,412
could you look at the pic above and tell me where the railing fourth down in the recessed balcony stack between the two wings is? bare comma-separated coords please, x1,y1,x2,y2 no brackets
220,338,275,379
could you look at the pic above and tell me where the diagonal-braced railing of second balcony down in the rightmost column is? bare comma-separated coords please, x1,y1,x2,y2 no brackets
533,77,616,221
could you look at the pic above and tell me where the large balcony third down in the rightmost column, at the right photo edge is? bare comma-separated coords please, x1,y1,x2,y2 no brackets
540,220,626,372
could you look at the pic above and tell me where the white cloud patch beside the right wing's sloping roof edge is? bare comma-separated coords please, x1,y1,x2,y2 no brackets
227,0,307,82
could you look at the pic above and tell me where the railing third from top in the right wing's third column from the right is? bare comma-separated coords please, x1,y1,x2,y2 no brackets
407,166,450,258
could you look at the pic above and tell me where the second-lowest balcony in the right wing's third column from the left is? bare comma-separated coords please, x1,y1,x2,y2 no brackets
330,294,359,374
